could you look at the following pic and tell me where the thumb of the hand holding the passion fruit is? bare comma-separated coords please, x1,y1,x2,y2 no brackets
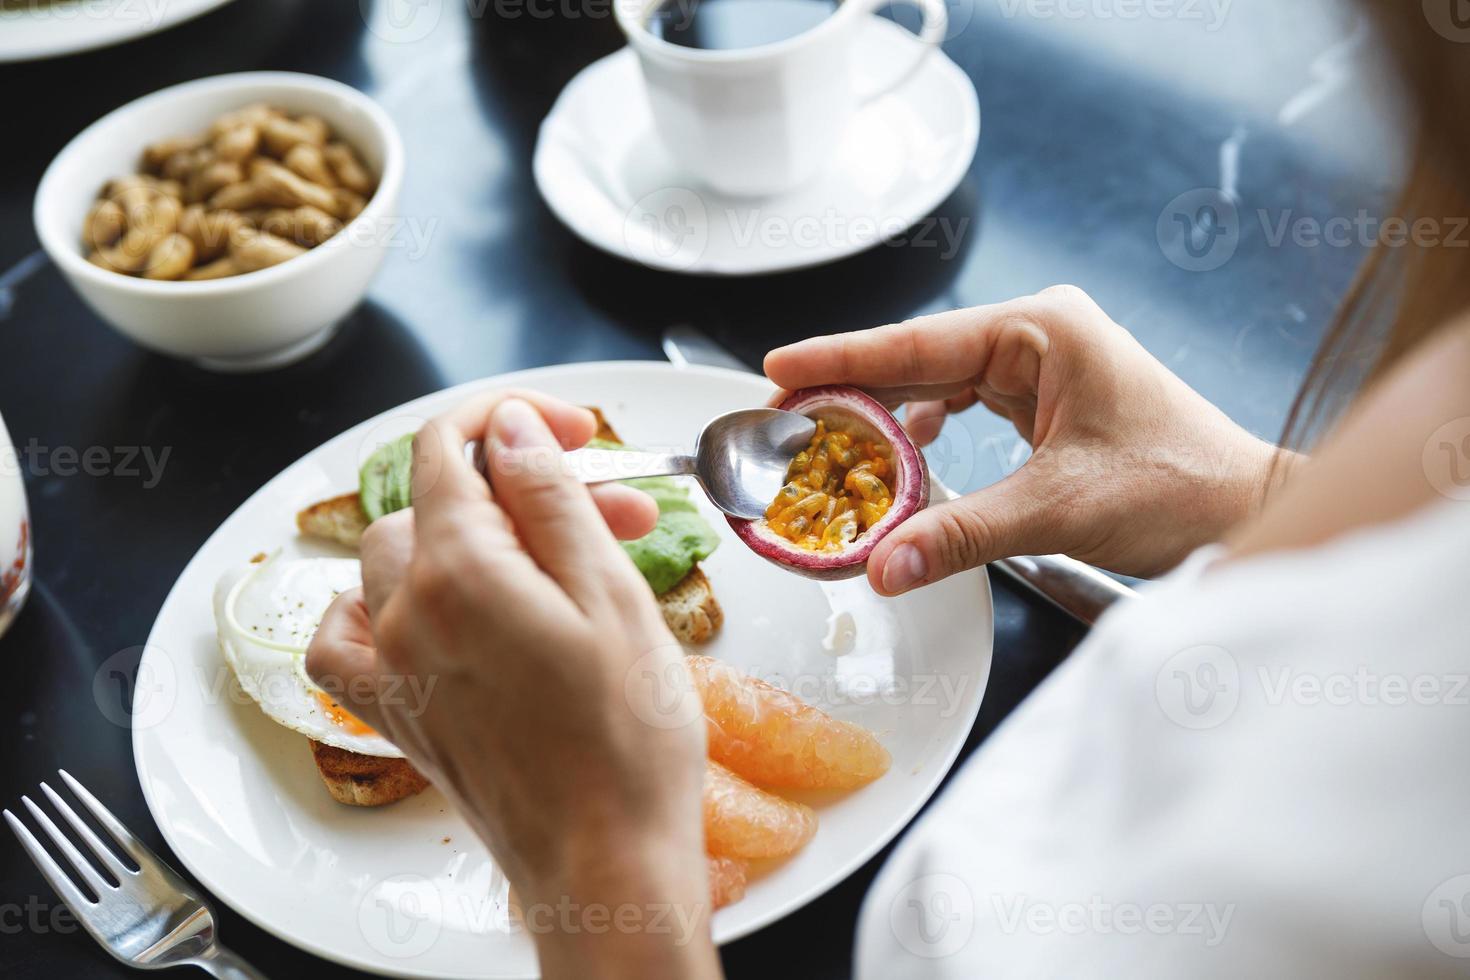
867,463,1055,595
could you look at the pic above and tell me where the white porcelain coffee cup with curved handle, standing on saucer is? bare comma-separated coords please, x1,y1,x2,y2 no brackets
613,0,948,197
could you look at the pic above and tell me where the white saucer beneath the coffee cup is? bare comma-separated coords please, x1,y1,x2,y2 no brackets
534,16,980,276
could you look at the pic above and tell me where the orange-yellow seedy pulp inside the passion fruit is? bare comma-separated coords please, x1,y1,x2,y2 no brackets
766,419,894,551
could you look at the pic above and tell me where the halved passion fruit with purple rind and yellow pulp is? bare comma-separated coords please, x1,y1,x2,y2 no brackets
728,385,929,580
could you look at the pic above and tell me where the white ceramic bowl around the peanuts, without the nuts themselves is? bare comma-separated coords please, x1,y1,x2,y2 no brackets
35,72,403,370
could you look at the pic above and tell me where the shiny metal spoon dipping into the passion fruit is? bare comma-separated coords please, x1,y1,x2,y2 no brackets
465,408,817,520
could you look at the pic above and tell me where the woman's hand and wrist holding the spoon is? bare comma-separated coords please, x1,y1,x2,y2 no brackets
307,395,719,977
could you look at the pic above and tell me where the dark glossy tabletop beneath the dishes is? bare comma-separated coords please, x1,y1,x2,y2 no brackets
0,0,1398,979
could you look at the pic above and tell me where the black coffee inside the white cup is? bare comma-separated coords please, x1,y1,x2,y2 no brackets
648,0,838,51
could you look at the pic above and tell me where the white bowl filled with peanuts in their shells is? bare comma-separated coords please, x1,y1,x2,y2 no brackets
35,72,403,370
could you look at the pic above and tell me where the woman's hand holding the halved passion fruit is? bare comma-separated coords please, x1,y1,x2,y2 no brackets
766,287,1276,595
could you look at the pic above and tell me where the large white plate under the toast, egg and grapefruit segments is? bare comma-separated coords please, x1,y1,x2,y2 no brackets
134,361,992,977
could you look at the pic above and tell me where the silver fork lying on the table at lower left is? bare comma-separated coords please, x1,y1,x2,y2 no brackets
4,770,266,980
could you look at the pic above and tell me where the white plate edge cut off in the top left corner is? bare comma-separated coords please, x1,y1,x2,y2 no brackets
0,0,229,62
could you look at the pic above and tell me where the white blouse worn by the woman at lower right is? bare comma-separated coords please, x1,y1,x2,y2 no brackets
857,502,1470,980
